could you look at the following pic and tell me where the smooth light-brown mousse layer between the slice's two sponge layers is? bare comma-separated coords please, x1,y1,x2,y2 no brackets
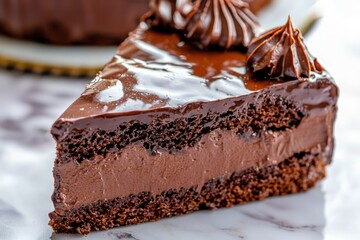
54,108,334,215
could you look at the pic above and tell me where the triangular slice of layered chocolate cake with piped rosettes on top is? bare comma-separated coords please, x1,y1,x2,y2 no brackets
49,0,338,234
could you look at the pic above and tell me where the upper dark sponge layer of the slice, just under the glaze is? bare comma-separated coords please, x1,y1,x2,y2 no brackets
55,94,305,164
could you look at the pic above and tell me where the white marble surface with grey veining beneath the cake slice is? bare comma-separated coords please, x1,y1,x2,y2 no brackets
0,0,360,240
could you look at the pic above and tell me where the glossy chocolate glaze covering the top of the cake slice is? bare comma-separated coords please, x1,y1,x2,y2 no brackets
53,24,337,130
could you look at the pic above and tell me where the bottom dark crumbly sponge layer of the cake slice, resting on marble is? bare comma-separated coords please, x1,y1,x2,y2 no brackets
49,147,326,234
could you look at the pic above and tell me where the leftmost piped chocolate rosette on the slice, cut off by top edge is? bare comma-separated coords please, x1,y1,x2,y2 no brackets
143,0,195,31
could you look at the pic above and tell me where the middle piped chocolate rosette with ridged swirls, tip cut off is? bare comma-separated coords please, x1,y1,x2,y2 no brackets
184,0,260,50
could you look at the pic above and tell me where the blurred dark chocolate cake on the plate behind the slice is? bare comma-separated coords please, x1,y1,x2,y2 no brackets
0,0,271,45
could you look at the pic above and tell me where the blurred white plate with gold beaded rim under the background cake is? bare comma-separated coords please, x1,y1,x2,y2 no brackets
0,0,319,75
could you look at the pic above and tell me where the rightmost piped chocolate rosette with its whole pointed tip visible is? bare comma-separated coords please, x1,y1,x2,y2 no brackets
247,16,322,80
